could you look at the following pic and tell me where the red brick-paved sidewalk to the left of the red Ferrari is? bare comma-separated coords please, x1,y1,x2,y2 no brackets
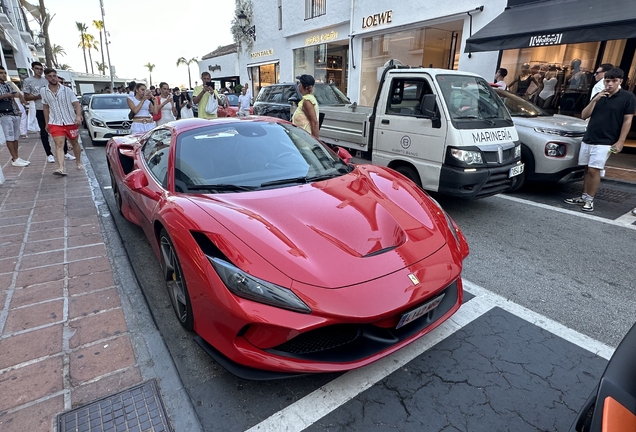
0,134,196,432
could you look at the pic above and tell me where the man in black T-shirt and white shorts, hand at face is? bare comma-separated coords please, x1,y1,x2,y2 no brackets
565,68,636,212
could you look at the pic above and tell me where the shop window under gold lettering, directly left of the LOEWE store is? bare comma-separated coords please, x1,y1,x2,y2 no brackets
293,28,349,94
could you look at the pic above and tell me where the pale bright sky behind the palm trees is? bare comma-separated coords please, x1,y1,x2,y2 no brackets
29,0,234,87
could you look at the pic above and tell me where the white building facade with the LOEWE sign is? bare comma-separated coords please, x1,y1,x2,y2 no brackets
238,0,506,104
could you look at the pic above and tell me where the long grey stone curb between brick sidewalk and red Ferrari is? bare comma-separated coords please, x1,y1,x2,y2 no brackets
82,144,202,432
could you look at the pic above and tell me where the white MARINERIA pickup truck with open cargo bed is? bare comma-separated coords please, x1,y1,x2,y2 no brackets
320,65,524,198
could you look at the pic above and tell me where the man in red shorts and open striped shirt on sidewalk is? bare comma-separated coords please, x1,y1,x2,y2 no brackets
40,69,84,176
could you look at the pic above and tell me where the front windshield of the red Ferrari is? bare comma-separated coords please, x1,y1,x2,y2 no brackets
174,120,350,193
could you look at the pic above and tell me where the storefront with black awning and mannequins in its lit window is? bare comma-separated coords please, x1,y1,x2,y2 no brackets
466,0,636,123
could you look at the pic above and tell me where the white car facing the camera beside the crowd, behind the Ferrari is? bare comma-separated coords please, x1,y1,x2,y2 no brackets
83,94,132,145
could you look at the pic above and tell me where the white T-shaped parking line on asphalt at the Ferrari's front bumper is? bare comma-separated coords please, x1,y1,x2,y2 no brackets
246,280,614,432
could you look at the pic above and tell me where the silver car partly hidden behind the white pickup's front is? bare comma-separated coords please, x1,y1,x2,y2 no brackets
495,89,587,189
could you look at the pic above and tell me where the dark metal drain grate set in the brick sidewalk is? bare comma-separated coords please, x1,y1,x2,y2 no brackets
57,379,172,432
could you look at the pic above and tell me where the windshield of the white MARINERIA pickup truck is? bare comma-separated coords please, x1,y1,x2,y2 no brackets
437,75,512,125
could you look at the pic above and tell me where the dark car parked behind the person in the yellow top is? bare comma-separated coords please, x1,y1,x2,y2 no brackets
253,83,351,120
